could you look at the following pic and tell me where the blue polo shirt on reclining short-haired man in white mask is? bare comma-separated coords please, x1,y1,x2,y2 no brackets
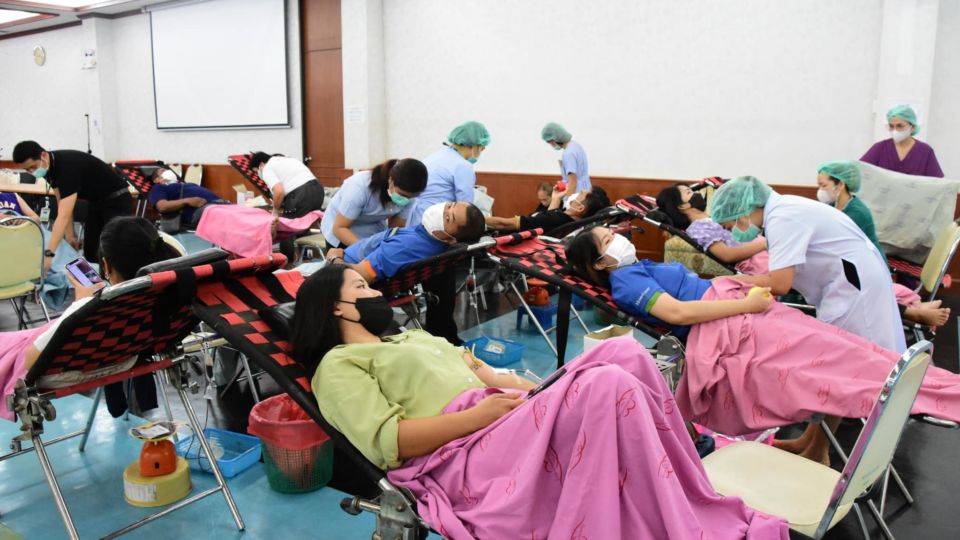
343,225,447,279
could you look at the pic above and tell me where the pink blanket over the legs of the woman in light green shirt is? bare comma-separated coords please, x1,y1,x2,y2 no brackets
389,337,788,539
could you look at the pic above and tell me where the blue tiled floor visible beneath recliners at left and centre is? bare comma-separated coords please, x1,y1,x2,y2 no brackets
0,304,628,540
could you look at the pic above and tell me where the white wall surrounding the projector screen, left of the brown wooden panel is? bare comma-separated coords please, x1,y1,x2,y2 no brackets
0,4,303,163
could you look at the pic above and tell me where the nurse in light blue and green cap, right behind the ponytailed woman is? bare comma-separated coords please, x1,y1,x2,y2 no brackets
407,121,490,227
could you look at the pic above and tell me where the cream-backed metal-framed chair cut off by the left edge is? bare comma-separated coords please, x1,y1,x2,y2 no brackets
0,216,50,330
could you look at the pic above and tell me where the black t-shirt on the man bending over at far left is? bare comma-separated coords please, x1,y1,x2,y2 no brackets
46,150,127,202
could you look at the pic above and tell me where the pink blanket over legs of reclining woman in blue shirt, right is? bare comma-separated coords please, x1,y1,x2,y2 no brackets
676,278,960,435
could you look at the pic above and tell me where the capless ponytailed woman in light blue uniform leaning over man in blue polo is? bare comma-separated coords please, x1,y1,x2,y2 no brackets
320,158,427,247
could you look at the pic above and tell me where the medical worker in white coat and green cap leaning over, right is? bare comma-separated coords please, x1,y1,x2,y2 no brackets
710,176,906,353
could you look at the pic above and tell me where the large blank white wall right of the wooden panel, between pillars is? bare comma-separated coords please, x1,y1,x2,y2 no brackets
376,0,892,184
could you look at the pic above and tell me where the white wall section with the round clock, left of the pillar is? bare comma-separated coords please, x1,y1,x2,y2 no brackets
0,26,93,160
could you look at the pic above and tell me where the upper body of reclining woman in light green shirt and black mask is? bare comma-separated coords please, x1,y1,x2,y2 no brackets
291,265,536,469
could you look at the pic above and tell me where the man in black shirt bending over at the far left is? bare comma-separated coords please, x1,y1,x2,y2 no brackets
13,141,133,270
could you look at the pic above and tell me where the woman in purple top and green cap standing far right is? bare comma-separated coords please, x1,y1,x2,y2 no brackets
860,105,943,178
